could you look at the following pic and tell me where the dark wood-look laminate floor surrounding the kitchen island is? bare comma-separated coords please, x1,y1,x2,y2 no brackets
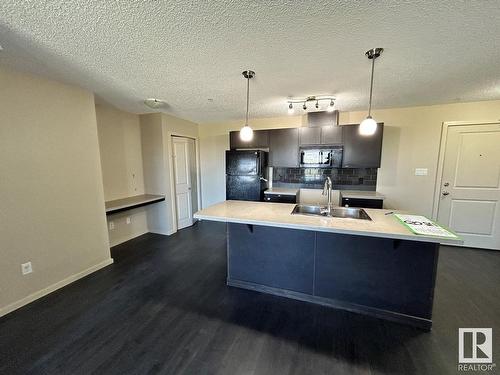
0,222,500,374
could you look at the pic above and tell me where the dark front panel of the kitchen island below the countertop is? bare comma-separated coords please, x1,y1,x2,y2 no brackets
227,223,439,330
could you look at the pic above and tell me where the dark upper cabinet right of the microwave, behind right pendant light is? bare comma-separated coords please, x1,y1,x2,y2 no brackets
342,123,384,168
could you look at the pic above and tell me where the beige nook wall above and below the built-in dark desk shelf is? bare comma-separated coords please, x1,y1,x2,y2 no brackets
96,103,148,246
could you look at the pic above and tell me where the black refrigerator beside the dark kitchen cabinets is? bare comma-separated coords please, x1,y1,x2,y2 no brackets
226,150,268,201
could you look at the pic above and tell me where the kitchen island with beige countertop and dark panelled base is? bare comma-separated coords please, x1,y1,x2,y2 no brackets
195,201,460,330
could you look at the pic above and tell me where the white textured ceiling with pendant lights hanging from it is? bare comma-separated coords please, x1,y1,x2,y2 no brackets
0,0,500,123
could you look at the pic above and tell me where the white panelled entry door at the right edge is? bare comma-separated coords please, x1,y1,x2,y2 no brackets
438,124,500,250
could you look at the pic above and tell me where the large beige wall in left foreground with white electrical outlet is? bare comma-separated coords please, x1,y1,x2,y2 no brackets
0,66,111,315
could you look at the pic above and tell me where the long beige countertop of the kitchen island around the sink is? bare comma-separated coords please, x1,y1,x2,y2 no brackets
194,201,462,245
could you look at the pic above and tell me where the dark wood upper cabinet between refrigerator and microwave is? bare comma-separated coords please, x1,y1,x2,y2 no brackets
269,128,300,167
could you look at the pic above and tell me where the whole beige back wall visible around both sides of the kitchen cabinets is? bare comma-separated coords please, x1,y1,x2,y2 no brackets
200,101,500,216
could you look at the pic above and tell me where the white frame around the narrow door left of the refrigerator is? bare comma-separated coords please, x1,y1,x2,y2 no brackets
168,133,203,234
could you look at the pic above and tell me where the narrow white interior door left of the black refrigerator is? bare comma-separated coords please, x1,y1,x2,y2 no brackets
172,137,193,229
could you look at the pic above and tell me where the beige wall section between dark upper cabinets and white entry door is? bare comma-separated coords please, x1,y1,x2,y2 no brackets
346,100,500,217
